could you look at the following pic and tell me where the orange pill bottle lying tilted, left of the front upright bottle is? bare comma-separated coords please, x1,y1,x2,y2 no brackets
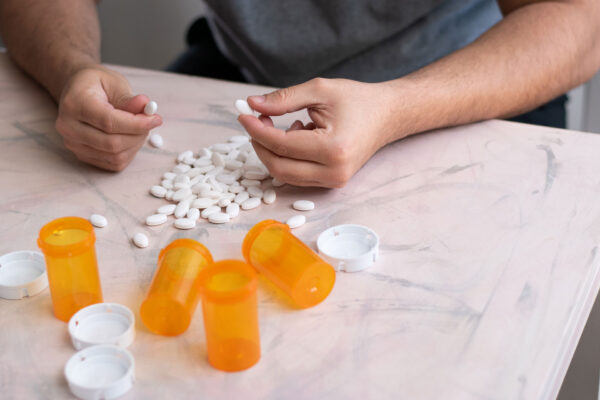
140,239,213,336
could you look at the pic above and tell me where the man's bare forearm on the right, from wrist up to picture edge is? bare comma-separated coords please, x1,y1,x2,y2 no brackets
387,1,600,141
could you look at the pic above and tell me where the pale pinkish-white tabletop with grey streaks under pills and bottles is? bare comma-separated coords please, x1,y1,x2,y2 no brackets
0,51,600,399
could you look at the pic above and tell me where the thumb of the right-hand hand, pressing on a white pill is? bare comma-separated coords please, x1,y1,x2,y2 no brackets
248,78,326,115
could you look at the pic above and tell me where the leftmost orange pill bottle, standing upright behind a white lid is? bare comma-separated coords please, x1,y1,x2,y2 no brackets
38,217,102,322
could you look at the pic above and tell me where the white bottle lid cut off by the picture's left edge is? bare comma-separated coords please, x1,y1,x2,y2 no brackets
0,250,48,300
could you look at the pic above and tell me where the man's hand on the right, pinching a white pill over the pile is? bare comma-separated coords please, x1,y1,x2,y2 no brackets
238,78,398,188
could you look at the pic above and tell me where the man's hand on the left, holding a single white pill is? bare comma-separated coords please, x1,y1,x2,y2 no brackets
56,65,162,171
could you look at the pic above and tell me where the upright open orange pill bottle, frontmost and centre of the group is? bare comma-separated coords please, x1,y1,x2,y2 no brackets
200,260,260,371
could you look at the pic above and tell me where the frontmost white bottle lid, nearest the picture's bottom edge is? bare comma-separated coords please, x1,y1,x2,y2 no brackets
65,345,135,400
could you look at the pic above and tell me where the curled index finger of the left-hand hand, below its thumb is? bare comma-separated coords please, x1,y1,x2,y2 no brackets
79,98,162,135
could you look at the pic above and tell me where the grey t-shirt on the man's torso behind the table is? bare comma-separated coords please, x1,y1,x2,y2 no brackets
205,0,502,87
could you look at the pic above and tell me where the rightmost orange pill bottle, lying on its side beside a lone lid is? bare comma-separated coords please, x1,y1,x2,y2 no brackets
242,220,335,308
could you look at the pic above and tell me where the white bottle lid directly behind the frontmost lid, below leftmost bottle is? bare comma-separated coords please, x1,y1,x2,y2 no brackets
69,303,135,350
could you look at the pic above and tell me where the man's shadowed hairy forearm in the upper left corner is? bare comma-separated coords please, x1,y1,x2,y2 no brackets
0,0,100,100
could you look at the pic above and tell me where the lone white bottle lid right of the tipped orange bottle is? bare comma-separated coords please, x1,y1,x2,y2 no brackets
317,224,379,272
